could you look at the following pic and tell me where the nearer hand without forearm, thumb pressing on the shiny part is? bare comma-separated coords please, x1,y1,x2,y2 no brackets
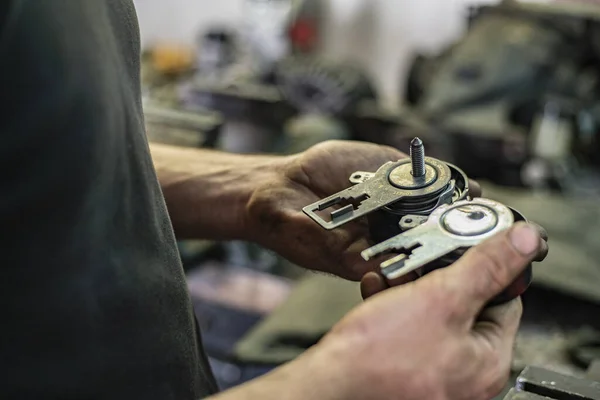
329,223,541,400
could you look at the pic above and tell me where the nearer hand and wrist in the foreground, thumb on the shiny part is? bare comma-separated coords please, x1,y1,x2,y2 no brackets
211,223,543,400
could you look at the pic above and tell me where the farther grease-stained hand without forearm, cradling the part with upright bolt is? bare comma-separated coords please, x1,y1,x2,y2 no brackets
241,141,479,280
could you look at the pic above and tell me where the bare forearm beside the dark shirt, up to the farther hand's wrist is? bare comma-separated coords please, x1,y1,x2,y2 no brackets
150,144,284,239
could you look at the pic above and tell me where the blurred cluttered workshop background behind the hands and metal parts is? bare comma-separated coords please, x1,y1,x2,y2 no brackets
136,0,600,398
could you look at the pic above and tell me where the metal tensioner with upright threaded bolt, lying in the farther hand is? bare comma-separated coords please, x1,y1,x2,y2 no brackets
303,138,469,242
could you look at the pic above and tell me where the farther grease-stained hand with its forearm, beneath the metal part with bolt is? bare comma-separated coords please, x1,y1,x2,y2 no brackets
151,141,480,280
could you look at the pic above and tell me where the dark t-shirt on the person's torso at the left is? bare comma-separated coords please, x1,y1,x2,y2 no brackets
0,0,215,400
